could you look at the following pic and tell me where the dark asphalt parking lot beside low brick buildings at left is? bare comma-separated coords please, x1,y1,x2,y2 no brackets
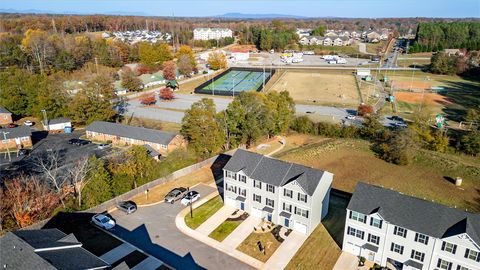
0,130,115,176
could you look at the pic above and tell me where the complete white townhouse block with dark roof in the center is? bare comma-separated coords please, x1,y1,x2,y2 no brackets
223,149,333,234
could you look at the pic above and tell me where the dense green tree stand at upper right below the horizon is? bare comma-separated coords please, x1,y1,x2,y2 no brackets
409,21,480,53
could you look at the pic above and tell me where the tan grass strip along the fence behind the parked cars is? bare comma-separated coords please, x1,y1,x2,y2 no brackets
132,167,214,205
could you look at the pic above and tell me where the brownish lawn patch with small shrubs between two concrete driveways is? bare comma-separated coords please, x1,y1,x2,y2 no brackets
237,232,281,262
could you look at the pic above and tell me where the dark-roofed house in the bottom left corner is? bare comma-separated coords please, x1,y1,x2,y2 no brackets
0,229,110,270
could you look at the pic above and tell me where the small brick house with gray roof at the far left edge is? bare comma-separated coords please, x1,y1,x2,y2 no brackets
0,126,32,150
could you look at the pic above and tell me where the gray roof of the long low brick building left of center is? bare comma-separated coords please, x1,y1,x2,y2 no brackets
87,121,177,145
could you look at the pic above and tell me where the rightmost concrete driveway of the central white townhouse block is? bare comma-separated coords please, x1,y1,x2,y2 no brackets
263,231,308,270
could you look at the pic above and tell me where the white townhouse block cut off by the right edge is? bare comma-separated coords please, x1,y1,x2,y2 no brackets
343,182,480,270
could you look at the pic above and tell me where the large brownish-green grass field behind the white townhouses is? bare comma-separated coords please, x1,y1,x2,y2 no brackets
277,139,480,212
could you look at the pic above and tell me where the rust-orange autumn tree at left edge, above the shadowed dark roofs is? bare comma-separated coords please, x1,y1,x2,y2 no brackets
0,177,60,228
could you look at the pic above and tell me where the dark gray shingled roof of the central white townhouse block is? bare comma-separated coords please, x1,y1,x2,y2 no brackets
224,149,324,196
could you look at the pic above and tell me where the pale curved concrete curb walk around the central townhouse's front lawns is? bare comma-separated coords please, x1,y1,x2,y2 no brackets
175,191,265,269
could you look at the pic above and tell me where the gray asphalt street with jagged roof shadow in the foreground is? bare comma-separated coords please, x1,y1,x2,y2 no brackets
111,185,252,269
